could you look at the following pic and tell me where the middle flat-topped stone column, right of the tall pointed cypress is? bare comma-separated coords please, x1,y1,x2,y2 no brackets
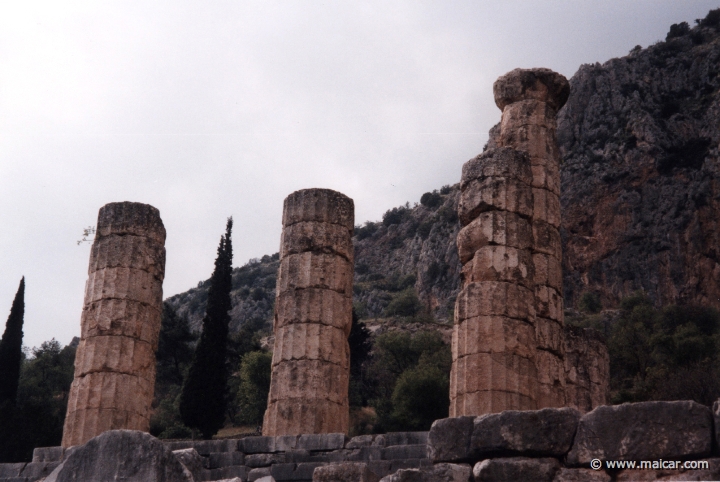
263,189,355,435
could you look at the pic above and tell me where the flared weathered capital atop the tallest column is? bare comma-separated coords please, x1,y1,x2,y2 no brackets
493,68,570,112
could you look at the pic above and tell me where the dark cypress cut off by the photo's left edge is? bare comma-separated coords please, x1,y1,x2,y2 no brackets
0,276,25,404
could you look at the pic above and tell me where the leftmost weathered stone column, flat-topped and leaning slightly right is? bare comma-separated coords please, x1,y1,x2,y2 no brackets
62,202,165,447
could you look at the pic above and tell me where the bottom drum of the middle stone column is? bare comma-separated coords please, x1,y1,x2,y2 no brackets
263,396,350,435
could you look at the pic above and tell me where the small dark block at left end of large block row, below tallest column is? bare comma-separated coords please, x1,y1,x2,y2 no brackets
427,417,475,463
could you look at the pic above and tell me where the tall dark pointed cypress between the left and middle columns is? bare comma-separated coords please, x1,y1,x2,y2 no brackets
180,217,232,439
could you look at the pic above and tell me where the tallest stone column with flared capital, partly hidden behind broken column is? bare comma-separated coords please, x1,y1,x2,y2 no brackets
493,69,570,409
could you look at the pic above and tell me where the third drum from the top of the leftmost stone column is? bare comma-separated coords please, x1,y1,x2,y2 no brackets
85,268,162,307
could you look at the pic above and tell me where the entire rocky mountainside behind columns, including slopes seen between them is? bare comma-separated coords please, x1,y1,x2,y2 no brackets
168,9,720,331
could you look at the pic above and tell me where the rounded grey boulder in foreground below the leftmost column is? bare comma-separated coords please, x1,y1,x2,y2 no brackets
45,430,193,482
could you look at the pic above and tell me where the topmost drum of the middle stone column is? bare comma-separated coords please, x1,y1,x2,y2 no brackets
282,189,355,232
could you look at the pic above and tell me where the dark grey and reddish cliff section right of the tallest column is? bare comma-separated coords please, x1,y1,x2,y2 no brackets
558,13,720,307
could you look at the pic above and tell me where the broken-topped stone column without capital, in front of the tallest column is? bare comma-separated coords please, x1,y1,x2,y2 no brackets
450,148,537,417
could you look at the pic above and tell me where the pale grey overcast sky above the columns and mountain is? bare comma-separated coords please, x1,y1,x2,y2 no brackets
0,0,720,347
